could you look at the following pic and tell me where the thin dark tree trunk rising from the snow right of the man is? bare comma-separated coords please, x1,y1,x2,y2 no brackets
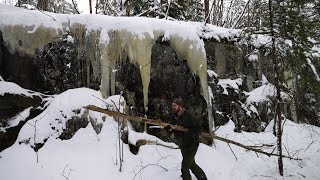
269,0,283,176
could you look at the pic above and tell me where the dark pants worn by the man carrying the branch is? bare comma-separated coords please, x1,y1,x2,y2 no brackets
180,146,207,180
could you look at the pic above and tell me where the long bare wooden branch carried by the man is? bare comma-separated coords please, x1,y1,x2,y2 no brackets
84,105,302,160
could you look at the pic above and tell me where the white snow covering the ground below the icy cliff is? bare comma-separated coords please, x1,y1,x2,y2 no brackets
0,81,320,180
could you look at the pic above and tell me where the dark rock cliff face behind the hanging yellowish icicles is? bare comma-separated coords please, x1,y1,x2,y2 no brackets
1,25,270,134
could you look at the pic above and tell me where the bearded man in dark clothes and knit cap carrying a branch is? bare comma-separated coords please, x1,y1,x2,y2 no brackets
166,98,207,180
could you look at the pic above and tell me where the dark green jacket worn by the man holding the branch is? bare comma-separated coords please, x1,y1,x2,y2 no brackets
174,110,201,148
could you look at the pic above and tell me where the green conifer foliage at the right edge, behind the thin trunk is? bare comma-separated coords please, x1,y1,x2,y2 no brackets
274,0,320,125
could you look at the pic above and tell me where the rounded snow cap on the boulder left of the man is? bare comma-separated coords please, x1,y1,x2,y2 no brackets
17,88,110,146
